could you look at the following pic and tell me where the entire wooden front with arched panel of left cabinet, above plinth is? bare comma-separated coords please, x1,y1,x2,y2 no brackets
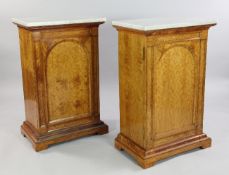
36,29,98,129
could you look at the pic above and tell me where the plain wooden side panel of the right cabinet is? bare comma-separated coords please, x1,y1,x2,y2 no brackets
119,31,146,147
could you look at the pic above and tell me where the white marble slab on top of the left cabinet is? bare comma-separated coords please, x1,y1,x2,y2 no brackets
12,18,106,27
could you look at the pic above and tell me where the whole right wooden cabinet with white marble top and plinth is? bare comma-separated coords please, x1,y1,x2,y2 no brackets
113,19,215,168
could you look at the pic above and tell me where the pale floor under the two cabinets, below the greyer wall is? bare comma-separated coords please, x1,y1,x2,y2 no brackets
0,79,229,175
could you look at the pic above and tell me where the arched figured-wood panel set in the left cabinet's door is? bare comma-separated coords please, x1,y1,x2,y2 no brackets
47,41,90,121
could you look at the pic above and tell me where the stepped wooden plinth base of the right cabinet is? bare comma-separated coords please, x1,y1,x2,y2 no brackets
115,134,211,168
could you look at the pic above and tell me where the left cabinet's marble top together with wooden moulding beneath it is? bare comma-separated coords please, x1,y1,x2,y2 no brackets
12,17,106,29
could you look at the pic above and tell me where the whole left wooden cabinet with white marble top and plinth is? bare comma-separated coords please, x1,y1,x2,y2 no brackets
13,18,108,151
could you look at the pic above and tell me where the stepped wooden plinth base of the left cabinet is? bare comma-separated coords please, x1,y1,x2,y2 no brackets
21,121,108,151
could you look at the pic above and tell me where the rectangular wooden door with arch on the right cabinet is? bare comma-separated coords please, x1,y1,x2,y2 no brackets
150,39,200,146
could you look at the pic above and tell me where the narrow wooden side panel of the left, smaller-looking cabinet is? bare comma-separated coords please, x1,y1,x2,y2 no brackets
19,28,39,128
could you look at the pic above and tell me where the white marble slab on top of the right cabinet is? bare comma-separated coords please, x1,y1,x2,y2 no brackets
112,18,216,31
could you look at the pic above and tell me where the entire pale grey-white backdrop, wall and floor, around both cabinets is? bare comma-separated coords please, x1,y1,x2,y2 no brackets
0,0,229,175
